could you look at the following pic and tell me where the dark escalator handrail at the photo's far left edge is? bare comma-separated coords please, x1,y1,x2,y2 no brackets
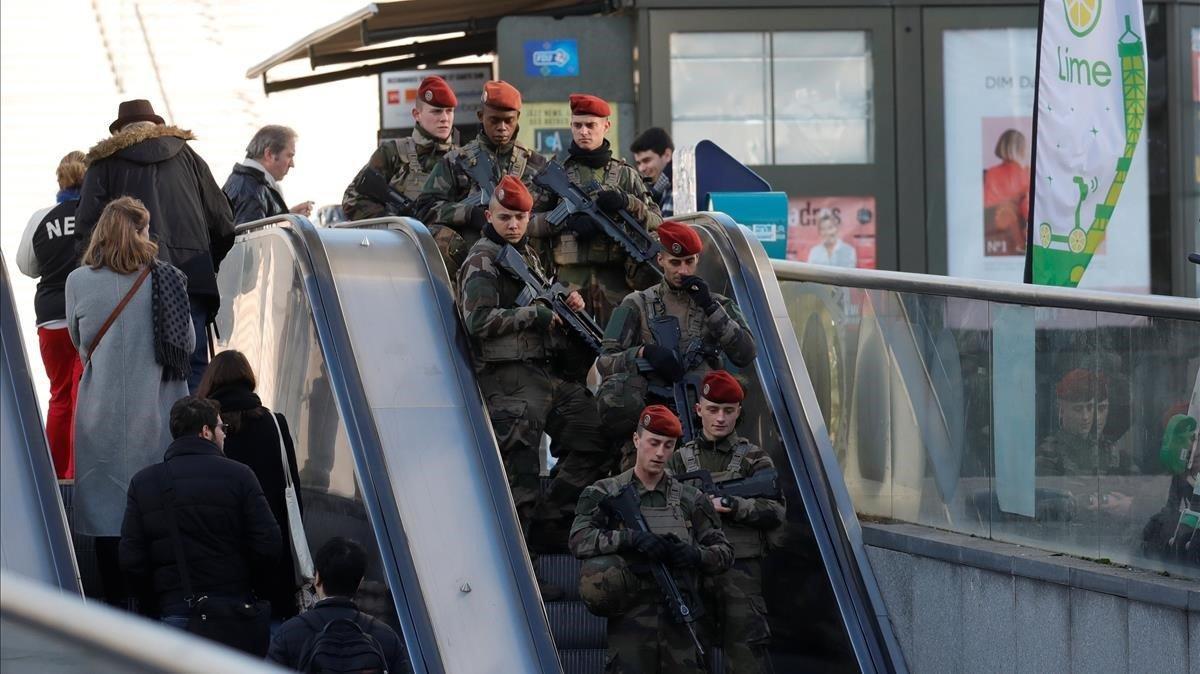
0,254,83,596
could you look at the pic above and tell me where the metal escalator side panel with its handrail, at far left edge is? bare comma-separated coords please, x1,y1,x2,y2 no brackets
0,254,83,596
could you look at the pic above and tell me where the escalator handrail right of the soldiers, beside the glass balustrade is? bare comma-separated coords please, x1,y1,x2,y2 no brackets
691,212,906,673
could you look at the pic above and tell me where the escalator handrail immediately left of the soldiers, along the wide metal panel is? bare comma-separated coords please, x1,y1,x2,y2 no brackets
334,217,562,673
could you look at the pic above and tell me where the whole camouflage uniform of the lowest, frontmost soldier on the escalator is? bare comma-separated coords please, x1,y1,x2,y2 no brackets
570,469,733,674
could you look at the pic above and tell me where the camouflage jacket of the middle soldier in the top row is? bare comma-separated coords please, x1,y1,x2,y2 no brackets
416,133,550,235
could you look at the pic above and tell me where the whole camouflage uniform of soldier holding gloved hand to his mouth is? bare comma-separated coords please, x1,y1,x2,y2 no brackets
596,281,757,468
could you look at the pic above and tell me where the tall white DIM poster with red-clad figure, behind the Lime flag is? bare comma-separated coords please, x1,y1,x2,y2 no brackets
942,26,1150,293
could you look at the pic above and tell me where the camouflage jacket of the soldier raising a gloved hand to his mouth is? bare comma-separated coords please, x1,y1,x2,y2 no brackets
596,281,757,377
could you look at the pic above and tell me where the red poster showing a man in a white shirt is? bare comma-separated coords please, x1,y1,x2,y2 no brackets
787,197,876,269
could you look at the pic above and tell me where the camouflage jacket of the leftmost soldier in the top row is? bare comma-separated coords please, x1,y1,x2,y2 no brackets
342,126,458,219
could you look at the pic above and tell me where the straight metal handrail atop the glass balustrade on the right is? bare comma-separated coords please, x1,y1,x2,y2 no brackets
770,260,1200,320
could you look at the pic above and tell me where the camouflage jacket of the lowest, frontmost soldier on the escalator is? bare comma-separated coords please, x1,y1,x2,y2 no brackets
568,469,733,574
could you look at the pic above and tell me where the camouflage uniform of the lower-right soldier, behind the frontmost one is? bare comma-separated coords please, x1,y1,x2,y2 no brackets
667,433,786,674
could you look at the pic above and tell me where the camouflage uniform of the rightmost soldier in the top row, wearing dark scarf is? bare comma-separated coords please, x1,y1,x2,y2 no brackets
529,140,662,327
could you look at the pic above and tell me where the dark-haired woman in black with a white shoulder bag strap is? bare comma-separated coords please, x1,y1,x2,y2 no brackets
196,350,308,621
